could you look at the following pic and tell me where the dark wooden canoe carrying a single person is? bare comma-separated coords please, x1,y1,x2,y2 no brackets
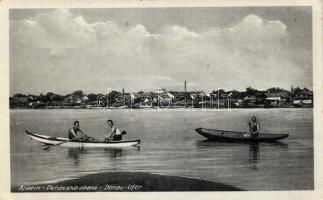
195,128,288,142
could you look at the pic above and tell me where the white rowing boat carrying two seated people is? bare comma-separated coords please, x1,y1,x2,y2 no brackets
26,131,140,148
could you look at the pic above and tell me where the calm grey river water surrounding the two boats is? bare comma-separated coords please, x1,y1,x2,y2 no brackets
10,109,313,190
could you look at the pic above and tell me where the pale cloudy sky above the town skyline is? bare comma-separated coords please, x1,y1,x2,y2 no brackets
9,7,312,95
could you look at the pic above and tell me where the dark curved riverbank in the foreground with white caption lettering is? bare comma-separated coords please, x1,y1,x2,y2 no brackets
11,172,241,192
